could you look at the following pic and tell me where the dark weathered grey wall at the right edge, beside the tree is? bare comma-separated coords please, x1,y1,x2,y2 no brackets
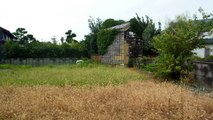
194,61,213,87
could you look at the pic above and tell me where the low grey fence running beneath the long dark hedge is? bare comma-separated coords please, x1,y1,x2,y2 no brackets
0,58,77,66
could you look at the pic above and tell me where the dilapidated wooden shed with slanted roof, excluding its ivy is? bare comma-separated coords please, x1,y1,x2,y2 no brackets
101,23,142,65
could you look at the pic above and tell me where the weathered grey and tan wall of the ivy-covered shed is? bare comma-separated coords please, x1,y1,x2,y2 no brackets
101,32,129,65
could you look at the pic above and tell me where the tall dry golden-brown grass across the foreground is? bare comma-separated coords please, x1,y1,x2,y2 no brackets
0,81,213,120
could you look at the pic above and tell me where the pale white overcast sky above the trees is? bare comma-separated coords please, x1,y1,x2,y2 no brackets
0,0,213,41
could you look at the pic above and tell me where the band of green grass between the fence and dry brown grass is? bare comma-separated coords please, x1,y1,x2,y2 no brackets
0,63,144,86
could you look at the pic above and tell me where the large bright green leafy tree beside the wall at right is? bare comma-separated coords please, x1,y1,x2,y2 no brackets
151,10,213,79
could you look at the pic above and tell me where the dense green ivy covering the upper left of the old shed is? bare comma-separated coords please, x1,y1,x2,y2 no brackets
97,29,118,55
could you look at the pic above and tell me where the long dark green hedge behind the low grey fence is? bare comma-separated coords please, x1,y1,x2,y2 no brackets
3,41,88,58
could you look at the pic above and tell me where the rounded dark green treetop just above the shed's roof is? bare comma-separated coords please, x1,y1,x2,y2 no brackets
102,18,125,29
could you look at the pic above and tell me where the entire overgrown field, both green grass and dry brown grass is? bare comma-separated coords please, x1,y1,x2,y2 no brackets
0,63,213,120
